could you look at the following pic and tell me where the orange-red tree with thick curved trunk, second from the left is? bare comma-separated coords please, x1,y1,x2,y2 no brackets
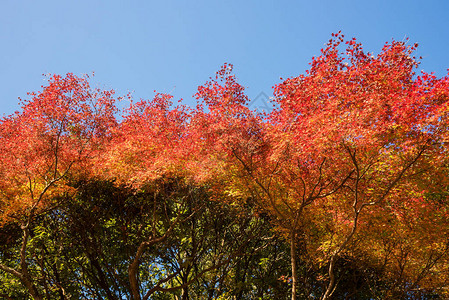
98,94,195,299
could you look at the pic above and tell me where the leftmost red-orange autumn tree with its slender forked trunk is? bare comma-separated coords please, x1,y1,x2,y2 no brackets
0,74,115,299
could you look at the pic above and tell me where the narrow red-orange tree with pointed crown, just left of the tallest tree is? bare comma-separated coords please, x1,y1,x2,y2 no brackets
190,64,308,295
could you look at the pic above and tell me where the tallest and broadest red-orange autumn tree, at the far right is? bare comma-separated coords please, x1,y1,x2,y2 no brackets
257,34,449,299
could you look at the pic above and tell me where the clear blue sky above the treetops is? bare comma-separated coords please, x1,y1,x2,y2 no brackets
0,0,449,115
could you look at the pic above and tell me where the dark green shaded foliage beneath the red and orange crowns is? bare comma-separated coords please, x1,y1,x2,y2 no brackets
0,179,289,299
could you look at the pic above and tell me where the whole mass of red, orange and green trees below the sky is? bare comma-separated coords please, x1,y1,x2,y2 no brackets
0,33,449,300
